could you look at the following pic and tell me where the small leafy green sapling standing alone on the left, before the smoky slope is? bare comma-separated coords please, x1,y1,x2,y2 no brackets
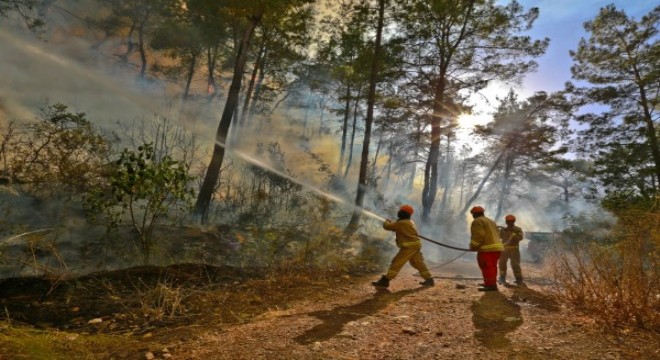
85,143,192,263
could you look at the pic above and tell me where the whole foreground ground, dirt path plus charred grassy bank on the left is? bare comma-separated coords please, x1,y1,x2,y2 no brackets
0,261,660,360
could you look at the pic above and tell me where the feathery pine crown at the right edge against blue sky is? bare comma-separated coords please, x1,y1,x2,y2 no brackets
568,5,660,199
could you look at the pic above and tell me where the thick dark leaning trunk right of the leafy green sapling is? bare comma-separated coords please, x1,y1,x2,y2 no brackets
194,14,262,223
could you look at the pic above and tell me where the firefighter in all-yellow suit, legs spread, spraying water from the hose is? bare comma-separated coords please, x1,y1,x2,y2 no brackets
372,205,435,288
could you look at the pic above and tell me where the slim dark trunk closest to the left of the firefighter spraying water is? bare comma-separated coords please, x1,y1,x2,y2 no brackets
346,0,386,234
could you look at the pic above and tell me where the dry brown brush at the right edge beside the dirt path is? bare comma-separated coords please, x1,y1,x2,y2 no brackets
551,212,660,331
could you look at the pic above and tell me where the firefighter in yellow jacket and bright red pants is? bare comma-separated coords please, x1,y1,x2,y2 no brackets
470,206,504,291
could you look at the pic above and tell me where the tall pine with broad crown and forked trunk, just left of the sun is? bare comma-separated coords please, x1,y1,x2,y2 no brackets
402,0,549,222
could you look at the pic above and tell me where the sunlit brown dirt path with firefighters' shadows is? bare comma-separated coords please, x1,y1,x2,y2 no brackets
175,262,660,360
